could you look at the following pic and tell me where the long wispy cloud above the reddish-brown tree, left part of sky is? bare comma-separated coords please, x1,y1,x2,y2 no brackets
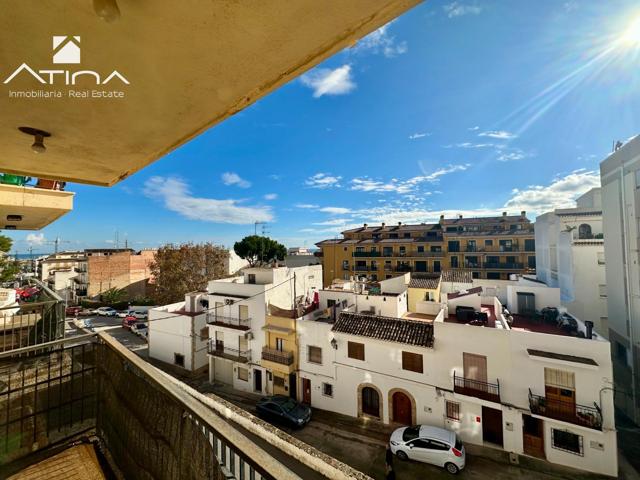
143,177,273,225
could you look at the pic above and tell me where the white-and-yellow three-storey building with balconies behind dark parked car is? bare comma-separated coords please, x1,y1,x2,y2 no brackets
207,265,322,396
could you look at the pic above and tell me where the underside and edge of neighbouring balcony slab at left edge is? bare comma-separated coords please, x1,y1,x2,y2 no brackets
0,184,74,230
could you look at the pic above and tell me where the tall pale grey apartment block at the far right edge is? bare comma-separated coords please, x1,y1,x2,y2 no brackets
600,136,640,424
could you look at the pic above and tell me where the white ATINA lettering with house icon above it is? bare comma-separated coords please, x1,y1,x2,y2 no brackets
3,35,130,85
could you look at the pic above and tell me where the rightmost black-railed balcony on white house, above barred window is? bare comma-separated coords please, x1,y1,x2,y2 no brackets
529,390,602,430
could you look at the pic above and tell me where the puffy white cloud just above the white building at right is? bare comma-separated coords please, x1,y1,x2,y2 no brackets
505,170,600,213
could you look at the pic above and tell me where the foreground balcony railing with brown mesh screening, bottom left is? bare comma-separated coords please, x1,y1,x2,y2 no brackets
0,333,360,480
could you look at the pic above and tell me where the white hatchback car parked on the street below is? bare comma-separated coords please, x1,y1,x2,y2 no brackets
389,425,466,474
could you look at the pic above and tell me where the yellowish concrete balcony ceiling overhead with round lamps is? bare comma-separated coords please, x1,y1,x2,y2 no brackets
0,0,419,186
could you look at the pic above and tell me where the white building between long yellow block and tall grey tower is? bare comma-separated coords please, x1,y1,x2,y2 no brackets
535,188,609,336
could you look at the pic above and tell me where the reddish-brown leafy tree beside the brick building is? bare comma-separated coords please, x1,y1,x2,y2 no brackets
151,243,229,305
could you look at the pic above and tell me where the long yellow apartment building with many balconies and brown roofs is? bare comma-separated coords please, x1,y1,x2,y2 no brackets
316,212,536,285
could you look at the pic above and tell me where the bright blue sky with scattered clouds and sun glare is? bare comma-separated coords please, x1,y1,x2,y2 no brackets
11,0,640,252
